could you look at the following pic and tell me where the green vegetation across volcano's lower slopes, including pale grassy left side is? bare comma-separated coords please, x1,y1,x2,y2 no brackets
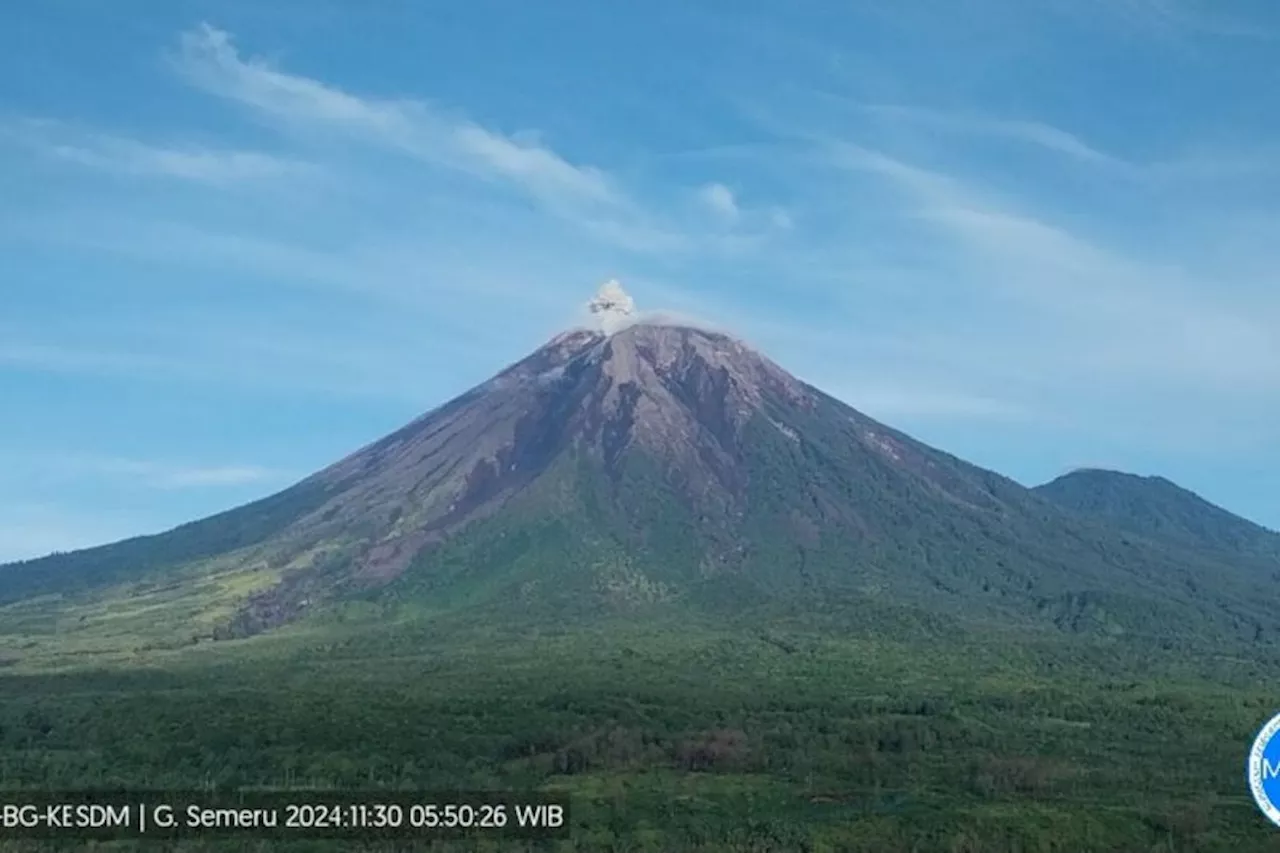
0,404,1280,665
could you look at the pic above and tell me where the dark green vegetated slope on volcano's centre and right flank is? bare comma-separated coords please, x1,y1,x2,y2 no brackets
337,411,1280,653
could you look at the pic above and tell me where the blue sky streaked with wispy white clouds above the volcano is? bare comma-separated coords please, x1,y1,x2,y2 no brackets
0,0,1280,558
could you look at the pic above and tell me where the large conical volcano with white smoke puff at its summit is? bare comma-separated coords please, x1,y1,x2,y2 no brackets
0,284,1280,643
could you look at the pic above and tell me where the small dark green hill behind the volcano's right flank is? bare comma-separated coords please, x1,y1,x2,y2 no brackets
1034,469,1280,560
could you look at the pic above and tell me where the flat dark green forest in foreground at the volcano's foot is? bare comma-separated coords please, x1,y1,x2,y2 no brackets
0,620,1280,853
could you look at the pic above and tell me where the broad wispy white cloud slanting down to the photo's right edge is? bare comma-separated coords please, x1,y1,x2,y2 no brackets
831,143,1280,391
